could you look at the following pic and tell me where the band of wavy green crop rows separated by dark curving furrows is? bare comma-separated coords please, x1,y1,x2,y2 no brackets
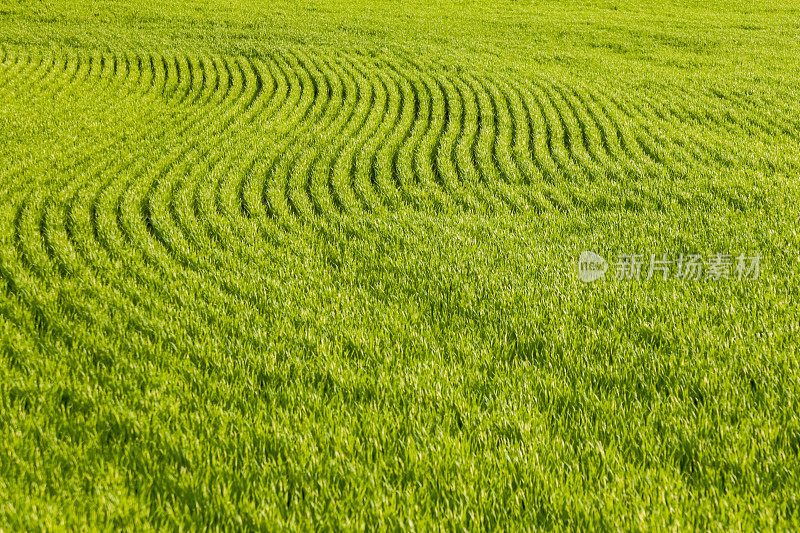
0,44,798,338
